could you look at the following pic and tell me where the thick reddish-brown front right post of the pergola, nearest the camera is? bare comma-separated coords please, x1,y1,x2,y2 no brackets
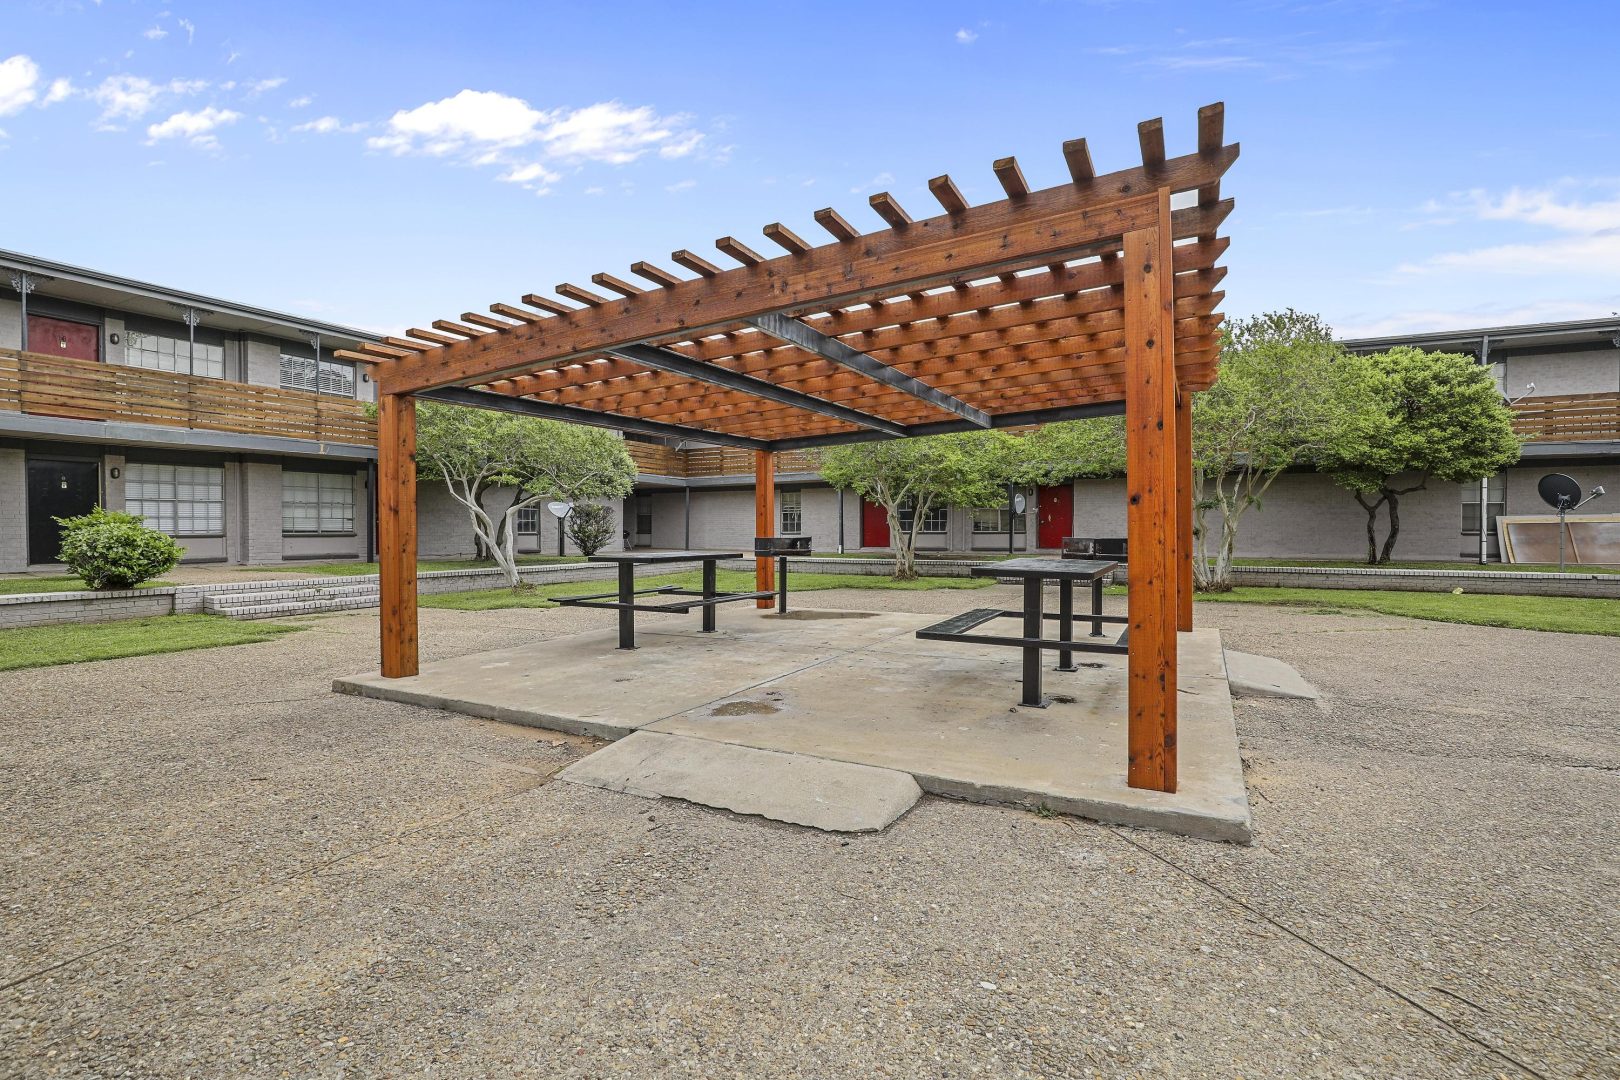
1124,191,1179,792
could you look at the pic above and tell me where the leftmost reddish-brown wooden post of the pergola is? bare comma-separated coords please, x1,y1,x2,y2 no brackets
377,393,416,678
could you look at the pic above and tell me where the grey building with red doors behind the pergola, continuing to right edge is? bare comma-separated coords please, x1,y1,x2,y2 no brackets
612,319,1620,560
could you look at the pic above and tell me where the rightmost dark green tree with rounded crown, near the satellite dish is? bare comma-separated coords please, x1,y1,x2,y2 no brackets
1319,345,1520,565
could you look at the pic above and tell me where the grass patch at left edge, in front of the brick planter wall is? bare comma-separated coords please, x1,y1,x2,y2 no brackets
0,615,303,672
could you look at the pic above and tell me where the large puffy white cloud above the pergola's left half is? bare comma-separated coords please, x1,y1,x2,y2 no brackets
366,89,705,189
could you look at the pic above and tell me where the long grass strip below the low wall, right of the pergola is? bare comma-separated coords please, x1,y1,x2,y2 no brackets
1199,588,1620,638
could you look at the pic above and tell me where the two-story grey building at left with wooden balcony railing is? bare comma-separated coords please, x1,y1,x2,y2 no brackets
0,251,609,572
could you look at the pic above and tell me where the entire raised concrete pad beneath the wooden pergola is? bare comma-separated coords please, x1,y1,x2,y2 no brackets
334,610,1251,844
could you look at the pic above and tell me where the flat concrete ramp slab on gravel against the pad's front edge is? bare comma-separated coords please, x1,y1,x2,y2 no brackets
557,730,922,832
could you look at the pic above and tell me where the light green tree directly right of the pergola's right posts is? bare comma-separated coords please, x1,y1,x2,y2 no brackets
1192,308,1371,593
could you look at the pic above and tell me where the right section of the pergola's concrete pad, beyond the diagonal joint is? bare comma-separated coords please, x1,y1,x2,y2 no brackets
650,630,1251,844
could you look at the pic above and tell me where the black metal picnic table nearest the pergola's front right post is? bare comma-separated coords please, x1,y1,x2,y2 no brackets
917,559,1129,709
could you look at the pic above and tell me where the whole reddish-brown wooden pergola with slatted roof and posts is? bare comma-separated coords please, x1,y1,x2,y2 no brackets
339,104,1238,792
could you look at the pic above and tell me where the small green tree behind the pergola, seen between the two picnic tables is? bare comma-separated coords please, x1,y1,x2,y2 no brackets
821,431,1006,581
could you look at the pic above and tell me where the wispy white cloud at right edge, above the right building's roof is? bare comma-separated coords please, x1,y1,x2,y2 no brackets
1400,180,1620,279
